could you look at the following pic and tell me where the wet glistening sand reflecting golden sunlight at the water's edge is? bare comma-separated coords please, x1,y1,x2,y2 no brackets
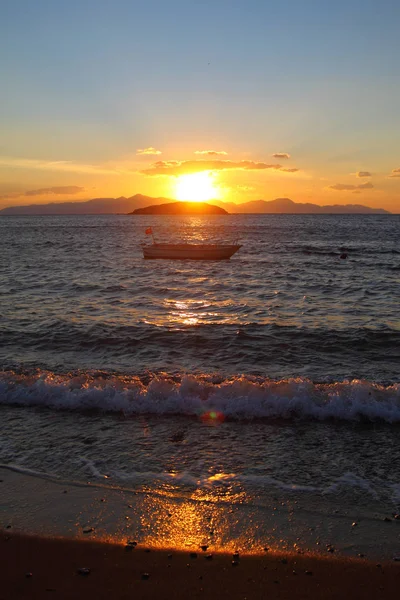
0,467,399,564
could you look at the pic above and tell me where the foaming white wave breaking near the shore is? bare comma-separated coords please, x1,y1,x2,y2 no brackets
0,371,400,424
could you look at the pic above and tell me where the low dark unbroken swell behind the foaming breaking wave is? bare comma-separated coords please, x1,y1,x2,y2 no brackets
2,322,400,350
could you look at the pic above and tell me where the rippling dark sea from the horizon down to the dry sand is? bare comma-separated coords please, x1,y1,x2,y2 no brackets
0,214,400,558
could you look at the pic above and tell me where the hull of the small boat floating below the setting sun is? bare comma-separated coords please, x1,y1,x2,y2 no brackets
142,243,242,260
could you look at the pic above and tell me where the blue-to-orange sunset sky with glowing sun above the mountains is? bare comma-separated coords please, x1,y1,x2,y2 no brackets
0,0,400,213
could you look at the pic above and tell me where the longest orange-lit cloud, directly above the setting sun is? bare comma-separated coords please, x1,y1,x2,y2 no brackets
141,160,298,176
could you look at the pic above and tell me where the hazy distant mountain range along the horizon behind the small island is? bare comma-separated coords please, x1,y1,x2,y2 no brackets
0,194,390,215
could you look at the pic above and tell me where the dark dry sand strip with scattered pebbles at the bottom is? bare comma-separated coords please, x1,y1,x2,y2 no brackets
0,531,400,600
